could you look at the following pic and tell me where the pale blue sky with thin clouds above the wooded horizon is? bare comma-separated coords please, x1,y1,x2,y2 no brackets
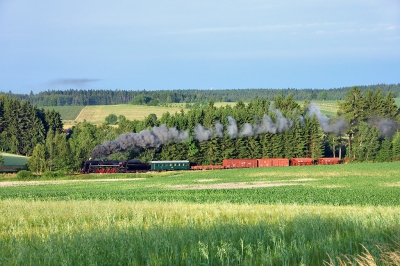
0,0,400,94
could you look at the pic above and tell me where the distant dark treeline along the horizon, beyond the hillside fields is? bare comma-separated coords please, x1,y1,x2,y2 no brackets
2,83,400,106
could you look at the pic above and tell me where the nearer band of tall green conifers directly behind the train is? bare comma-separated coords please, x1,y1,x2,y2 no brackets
0,87,400,172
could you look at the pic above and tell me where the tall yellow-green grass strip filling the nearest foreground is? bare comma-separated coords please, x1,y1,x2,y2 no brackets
0,200,400,265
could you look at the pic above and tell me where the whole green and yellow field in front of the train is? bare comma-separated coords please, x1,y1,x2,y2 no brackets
0,163,400,265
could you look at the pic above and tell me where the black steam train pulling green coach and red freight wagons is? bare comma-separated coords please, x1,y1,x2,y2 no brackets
81,157,342,174
